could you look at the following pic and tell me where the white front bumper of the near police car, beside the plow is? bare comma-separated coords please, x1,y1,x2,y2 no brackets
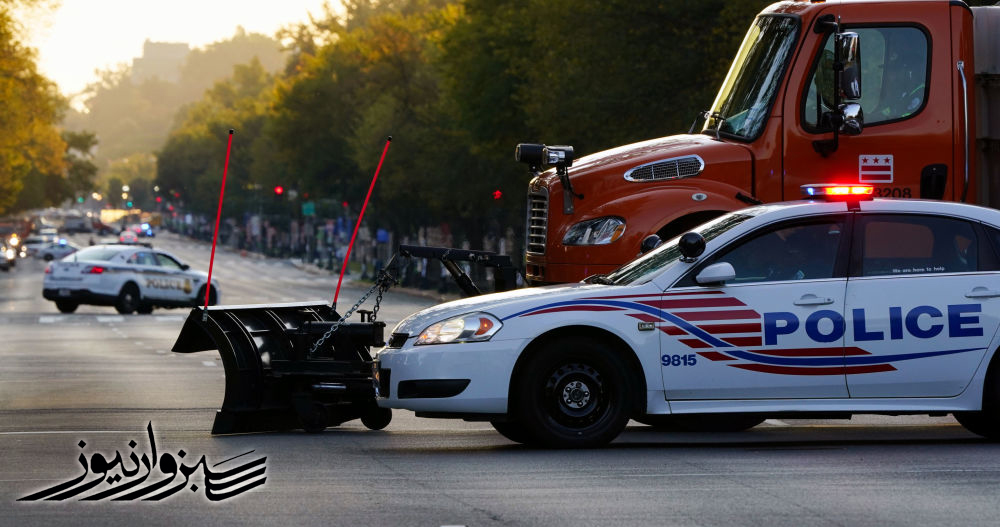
376,339,526,414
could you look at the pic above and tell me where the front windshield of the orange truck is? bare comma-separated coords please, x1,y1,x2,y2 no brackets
704,16,799,140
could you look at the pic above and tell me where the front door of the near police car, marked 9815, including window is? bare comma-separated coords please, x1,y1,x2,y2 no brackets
660,214,849,400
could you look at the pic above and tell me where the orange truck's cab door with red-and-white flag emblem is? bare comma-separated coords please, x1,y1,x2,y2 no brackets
784,2,962,200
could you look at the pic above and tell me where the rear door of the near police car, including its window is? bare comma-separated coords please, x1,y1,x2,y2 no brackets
846,214,1000,397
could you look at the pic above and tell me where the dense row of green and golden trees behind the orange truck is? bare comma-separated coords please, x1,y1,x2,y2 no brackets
157,0,769,246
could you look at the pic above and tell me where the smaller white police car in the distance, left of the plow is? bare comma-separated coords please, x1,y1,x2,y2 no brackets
42,244,220,314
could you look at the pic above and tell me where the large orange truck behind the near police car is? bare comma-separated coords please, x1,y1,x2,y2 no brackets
516,0,1000,284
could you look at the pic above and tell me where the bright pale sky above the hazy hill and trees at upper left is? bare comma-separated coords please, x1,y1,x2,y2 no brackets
24,0,330,100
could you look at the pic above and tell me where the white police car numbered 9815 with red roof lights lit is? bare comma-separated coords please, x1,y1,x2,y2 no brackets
376,186,1000,447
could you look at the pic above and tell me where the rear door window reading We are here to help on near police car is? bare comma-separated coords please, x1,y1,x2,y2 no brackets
857,214,979,276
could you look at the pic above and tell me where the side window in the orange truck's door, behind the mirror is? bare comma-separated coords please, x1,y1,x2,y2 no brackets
802,27,928,133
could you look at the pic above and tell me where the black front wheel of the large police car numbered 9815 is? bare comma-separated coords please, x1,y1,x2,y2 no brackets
512,337,633,448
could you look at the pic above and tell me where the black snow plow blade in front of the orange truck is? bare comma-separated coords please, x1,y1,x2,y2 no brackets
173,302,391,434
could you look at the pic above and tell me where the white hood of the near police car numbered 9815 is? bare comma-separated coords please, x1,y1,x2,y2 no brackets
392,282,622,337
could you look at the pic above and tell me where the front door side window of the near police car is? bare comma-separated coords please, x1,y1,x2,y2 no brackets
678,216,846,286
